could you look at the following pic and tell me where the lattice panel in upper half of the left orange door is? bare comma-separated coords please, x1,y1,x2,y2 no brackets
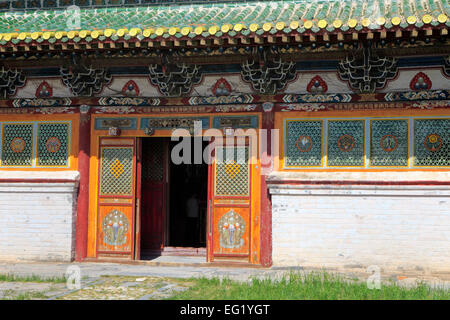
101,147,133,195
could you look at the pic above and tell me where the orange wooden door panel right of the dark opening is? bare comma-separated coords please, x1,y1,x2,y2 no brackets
207,145,251,261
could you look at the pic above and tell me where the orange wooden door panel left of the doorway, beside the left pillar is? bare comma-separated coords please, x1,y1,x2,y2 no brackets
97,138,136,259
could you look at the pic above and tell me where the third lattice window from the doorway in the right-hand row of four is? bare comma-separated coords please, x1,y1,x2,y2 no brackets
370,120,408,167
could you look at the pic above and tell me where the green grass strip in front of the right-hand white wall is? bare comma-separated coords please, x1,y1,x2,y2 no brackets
170,273,450,300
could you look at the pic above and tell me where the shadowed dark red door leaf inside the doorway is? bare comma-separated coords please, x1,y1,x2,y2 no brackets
141,138,168,255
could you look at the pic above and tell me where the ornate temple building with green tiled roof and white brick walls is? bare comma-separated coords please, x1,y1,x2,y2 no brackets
0,0,450,272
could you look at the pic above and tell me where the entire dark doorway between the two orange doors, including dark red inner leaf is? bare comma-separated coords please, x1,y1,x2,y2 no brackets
140,137,208,259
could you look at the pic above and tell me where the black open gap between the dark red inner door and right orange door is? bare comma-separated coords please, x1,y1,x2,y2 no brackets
168,138,208,248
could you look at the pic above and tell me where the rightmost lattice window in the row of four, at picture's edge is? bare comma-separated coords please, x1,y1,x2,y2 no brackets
414,119,450,167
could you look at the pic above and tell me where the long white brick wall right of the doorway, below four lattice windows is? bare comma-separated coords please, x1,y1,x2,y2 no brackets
269,173,450,272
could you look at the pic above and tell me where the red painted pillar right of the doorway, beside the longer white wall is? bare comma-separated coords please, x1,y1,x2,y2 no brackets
260,102,274,267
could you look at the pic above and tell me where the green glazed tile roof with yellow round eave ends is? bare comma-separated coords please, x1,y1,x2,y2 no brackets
0,0,450,41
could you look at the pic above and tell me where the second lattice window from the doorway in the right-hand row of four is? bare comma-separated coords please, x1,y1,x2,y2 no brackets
327,120,365,167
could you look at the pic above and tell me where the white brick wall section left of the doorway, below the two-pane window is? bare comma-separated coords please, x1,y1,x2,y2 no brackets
0,171,79,261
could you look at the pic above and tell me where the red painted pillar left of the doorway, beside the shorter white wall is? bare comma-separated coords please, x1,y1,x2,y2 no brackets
75,106,91,261
